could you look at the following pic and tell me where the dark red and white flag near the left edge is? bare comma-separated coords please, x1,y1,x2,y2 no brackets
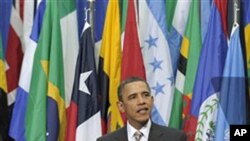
6,1,24,105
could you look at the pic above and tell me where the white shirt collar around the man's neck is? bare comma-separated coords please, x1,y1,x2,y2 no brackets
127,119,152,139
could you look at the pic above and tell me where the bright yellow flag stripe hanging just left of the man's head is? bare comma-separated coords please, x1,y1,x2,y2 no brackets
100,0,123,132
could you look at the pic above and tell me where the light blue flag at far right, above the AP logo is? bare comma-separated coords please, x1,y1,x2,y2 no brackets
215,23,248,141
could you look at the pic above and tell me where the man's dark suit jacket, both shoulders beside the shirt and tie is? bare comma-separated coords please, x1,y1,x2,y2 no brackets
97,123,186,141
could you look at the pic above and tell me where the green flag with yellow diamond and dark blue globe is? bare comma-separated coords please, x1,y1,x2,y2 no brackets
25,0,67,141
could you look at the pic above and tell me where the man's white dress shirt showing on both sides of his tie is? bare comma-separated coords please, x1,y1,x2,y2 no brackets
127,120,152,141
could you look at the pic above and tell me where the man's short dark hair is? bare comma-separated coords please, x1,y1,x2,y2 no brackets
118,76,151,101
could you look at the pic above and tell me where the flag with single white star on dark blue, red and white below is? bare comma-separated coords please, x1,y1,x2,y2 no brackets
66,23,102,141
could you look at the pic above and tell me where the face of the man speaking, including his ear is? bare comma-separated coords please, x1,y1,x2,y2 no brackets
118,81,153,128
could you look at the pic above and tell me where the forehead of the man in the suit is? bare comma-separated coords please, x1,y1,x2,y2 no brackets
123,81,149,94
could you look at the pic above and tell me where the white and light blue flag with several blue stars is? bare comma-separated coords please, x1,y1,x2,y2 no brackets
139,0,174,126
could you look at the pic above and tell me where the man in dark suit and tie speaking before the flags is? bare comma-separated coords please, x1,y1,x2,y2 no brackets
97,77,186,141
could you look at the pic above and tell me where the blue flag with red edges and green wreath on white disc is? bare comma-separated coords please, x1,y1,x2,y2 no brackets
183,0,227,140
